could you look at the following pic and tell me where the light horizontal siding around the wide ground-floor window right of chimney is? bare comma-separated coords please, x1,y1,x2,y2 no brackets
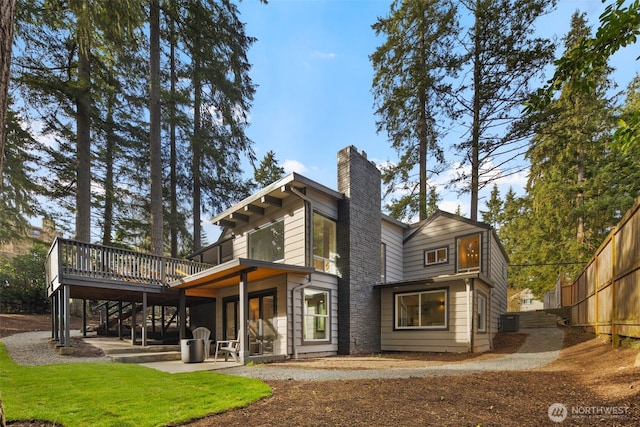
381,281,468,353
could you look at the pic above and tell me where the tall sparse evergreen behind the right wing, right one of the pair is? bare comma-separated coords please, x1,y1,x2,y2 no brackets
457,0,556,220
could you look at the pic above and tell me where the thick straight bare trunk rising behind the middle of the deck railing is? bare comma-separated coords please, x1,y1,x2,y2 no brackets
149,0,164,255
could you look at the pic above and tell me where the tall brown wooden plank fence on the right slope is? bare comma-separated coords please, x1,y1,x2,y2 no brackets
550,198,640,342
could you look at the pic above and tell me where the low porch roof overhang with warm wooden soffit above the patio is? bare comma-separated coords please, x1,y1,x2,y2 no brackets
169,258,315,296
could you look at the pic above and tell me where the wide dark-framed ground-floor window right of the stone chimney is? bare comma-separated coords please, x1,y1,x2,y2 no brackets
396,289,447,329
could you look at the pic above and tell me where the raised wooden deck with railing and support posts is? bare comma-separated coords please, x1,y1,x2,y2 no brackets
45,237,212,347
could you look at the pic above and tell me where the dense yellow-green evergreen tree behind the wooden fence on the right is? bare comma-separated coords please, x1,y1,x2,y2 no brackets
516,13,637,296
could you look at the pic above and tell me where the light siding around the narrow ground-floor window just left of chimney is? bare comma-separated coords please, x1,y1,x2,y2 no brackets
287,273,338,358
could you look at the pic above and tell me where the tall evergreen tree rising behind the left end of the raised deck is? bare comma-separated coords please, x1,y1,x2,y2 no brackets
16,0,142,241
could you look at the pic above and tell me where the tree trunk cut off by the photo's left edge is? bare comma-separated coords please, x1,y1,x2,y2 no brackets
0,0,16,193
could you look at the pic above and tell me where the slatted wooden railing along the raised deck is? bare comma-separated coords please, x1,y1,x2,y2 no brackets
46,237,211,286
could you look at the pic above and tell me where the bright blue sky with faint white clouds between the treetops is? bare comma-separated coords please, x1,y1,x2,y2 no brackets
222,0,638,227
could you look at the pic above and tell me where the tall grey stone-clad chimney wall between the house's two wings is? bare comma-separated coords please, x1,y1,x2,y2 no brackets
337,146,382,354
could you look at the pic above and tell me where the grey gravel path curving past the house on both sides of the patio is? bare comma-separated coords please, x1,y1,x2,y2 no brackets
1,328,564,381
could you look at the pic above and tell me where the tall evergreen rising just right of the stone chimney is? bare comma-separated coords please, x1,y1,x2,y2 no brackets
370,0,459,224
